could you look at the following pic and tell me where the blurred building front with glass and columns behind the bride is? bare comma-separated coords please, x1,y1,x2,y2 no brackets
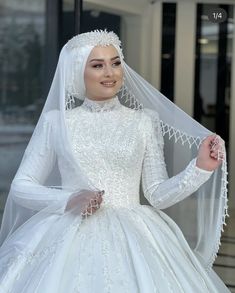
0,0,235,292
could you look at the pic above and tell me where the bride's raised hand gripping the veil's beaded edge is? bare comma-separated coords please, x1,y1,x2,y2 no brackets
196,134,224,171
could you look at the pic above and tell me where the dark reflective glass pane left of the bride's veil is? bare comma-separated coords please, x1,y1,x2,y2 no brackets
0,0,45,222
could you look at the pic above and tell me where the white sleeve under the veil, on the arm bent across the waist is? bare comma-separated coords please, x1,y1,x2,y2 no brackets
11,110,71,213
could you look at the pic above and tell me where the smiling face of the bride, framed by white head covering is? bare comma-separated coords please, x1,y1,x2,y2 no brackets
84,45,123,100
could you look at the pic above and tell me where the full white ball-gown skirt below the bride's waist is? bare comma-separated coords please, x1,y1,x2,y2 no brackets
0,205,229,293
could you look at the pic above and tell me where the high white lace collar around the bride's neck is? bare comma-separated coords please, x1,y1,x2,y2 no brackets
82,96,121,112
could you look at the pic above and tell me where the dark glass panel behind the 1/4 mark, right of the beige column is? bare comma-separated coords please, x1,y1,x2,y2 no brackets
194,4,233,142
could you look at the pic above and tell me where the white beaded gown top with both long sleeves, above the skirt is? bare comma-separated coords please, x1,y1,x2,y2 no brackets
13,97,212,210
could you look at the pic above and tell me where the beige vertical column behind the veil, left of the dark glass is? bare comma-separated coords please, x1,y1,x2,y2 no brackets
174,1,196,116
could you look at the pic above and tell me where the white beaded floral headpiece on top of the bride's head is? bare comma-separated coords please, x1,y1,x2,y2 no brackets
66,29,121,50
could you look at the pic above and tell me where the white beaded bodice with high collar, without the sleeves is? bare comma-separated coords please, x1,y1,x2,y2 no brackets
67,97,145,206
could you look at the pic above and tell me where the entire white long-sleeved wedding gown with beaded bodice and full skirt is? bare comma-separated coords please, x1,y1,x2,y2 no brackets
0,97,229,293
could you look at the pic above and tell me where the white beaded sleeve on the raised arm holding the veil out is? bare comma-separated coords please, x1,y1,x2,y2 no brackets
142,110,213,209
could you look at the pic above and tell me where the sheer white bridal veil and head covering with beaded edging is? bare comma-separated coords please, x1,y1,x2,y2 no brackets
0,31,227,270
